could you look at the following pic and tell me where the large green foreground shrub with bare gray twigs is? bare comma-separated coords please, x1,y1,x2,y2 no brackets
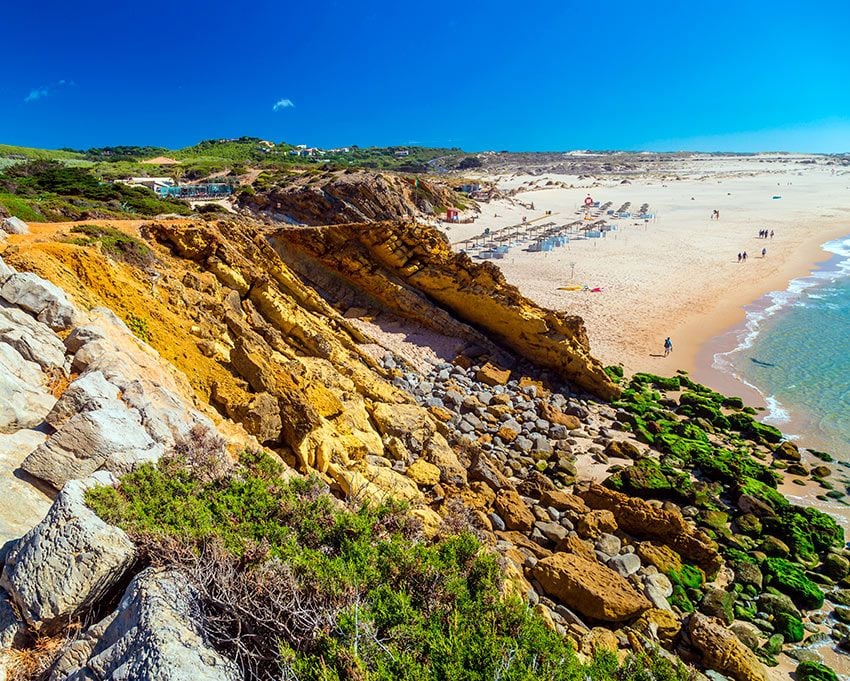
86,452,690,681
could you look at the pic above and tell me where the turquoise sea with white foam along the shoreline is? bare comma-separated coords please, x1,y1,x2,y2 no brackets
714,236,850,462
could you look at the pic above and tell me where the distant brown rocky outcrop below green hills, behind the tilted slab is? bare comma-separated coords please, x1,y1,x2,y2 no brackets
239,171,474,225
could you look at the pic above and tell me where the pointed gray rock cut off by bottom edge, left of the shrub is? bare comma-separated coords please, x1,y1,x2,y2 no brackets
59,568,241,681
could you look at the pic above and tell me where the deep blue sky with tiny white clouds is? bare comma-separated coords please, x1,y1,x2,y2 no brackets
0,0,850,151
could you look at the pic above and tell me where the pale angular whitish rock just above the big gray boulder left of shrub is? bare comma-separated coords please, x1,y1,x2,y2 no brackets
21,402,165,489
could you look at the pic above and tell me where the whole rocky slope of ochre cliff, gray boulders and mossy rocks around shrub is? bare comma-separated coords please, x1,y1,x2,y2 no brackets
0,214,850,681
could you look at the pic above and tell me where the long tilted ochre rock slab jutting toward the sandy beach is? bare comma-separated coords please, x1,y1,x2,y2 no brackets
272,222,618,399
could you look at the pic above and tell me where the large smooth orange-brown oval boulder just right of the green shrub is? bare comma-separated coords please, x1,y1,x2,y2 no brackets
531,553,651,622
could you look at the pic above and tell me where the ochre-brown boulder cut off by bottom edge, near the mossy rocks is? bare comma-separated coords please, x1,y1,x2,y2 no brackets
688,613,768,681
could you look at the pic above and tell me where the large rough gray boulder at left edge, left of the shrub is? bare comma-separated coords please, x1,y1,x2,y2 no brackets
0,475,135,631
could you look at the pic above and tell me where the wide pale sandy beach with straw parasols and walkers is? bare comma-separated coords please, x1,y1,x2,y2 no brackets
441,154,850,392
